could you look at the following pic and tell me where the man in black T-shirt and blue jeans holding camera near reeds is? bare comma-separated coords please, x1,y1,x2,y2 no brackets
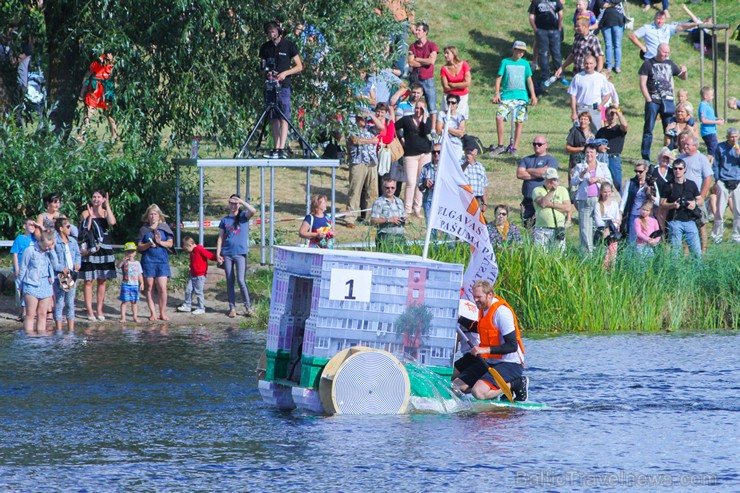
660,159,704,259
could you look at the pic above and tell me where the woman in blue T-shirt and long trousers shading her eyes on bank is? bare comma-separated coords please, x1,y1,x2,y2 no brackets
216,194,257,318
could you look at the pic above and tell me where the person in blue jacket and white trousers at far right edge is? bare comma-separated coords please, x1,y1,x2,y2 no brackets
712,127,740,243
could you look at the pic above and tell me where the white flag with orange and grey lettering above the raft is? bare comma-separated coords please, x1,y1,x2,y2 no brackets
427,131,498,300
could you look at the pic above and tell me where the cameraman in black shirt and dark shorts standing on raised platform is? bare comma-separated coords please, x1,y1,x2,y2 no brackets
260,21,303,159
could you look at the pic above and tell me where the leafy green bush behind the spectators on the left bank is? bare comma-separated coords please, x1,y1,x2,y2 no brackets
0,113,198,242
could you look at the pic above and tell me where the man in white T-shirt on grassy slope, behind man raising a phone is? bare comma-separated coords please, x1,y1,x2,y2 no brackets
568,55,612,132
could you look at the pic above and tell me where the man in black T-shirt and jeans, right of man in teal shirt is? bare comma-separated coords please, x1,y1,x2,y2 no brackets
529,0,568,85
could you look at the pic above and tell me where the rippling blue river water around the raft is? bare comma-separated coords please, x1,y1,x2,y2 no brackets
0,328,740,493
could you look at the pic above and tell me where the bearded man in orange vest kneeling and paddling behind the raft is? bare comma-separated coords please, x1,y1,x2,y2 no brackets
453,281,529,402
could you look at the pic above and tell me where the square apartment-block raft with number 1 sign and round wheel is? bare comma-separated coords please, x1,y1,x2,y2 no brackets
259,247,540,414
